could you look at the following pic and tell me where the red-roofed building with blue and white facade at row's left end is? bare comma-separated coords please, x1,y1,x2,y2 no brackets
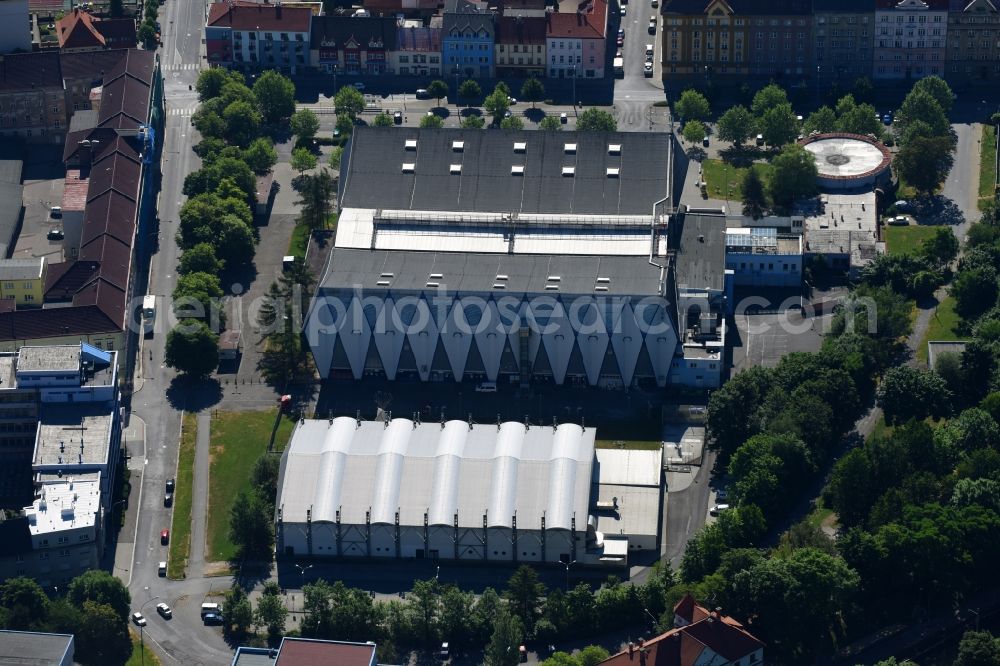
205,0,312,74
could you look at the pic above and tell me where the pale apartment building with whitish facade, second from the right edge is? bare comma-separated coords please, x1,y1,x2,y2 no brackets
872,0,948,81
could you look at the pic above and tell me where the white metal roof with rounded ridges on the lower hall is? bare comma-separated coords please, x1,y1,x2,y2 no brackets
278,417,595,529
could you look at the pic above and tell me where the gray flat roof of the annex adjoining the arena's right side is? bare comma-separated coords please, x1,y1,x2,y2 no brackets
672,213,726,291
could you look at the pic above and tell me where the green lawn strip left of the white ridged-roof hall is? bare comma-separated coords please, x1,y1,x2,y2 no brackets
205,409,295,562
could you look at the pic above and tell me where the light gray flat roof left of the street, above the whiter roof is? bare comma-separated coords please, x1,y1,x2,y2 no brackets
32,403,111,466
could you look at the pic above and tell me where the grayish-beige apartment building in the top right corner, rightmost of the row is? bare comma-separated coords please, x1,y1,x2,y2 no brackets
945,0,1000,86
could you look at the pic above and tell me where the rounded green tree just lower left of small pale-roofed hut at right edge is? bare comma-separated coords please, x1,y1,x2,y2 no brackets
876,365,951,424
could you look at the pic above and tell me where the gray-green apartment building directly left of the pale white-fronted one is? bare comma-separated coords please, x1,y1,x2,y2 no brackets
813,0,875,85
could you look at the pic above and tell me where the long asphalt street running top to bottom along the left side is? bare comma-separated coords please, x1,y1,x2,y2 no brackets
117,0,232,665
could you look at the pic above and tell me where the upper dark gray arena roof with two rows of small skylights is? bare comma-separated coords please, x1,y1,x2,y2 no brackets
341,127,671,215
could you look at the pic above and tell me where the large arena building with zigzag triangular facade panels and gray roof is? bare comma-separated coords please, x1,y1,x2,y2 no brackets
305,127,726,388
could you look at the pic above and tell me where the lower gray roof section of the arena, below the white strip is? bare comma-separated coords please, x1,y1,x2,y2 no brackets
322,245,668,296
